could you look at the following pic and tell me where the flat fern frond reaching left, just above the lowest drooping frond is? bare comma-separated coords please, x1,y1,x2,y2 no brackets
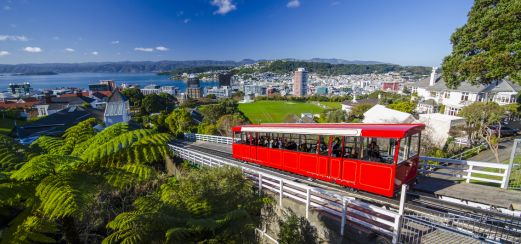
11,154,83,181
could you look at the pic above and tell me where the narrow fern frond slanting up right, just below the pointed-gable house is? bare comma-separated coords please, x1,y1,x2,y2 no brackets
72,123,128,156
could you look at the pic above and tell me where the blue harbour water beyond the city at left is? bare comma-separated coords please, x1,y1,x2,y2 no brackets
0,73,218,91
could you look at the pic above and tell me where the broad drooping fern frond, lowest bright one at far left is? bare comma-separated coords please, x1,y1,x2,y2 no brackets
36,173,99,219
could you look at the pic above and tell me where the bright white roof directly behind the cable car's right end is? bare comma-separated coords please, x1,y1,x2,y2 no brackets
363,104,416,124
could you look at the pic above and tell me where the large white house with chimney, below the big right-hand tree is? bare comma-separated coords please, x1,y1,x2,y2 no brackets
411,67,521,115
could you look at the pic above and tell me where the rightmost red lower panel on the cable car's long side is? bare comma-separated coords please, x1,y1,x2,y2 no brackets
357,162,395,197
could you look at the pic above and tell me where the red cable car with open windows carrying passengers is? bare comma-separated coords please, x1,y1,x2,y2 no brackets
232,124,425,197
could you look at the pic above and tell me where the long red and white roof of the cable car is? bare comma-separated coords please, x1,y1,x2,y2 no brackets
233,123,425,138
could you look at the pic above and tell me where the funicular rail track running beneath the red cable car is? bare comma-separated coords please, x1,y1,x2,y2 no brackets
176,142,521,243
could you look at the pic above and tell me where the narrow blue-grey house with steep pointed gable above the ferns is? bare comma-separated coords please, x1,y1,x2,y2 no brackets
103,90,130,127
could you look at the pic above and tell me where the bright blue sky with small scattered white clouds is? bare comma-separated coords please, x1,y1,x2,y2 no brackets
0,0,472,66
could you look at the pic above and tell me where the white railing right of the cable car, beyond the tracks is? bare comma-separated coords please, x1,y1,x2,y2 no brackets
418,157,510,188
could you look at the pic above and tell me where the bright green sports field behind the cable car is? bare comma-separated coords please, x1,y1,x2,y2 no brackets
239,101,328,124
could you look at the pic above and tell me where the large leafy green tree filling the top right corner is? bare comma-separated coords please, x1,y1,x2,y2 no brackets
443,0,521,87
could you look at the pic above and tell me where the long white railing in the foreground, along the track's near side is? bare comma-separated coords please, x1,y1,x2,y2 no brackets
169,144,406,243
